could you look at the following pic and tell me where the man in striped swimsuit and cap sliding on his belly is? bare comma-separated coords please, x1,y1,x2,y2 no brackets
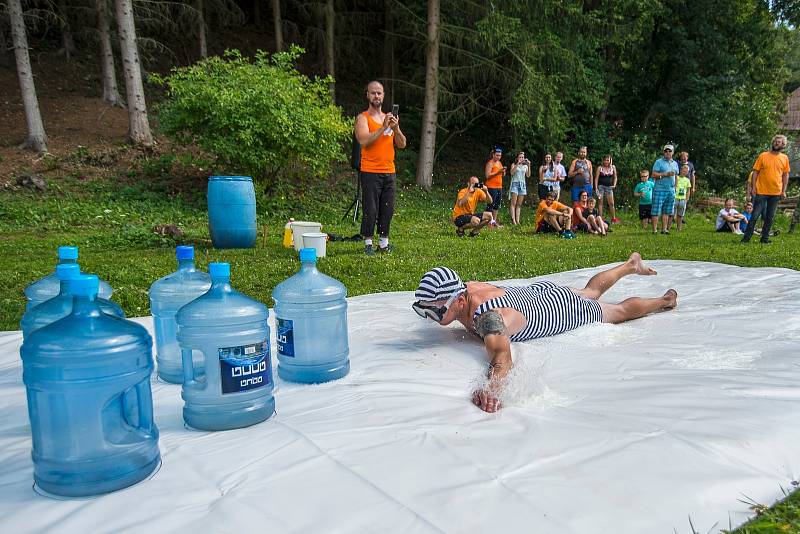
412,252,678,412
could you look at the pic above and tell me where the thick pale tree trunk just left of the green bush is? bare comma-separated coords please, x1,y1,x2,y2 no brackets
116,0,153,147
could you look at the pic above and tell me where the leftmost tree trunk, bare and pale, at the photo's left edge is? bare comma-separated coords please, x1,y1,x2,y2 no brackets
6,0,47,152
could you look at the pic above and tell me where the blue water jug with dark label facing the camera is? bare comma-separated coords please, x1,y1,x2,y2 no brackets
177,263,275,430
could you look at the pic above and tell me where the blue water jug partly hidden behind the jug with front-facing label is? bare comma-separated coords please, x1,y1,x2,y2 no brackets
150,246,211,384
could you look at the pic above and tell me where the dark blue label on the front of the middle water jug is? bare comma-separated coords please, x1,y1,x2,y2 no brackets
219,340,272,395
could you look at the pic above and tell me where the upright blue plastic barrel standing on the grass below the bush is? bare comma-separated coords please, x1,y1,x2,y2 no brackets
208,176,256,248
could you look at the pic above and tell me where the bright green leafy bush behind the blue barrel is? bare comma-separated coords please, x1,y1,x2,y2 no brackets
151,46,351,186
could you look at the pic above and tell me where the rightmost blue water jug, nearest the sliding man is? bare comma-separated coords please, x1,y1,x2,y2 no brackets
272,248,350,383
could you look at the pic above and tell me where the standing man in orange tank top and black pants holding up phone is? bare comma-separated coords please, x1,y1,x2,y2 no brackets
355,81,406,256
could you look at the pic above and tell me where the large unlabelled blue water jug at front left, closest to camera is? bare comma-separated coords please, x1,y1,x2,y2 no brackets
20,275,160,497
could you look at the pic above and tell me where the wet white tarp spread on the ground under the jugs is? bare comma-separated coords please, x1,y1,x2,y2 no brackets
0,261,800,534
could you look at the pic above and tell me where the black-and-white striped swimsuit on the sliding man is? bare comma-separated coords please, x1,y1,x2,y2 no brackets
472,282,603,341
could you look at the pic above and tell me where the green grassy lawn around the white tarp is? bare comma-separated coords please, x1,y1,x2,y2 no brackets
0,172,800,533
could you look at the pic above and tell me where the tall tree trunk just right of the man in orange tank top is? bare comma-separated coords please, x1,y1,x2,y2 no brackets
417,0,439,191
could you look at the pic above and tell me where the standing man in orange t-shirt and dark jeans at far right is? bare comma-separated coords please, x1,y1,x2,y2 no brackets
742,135,789,243
